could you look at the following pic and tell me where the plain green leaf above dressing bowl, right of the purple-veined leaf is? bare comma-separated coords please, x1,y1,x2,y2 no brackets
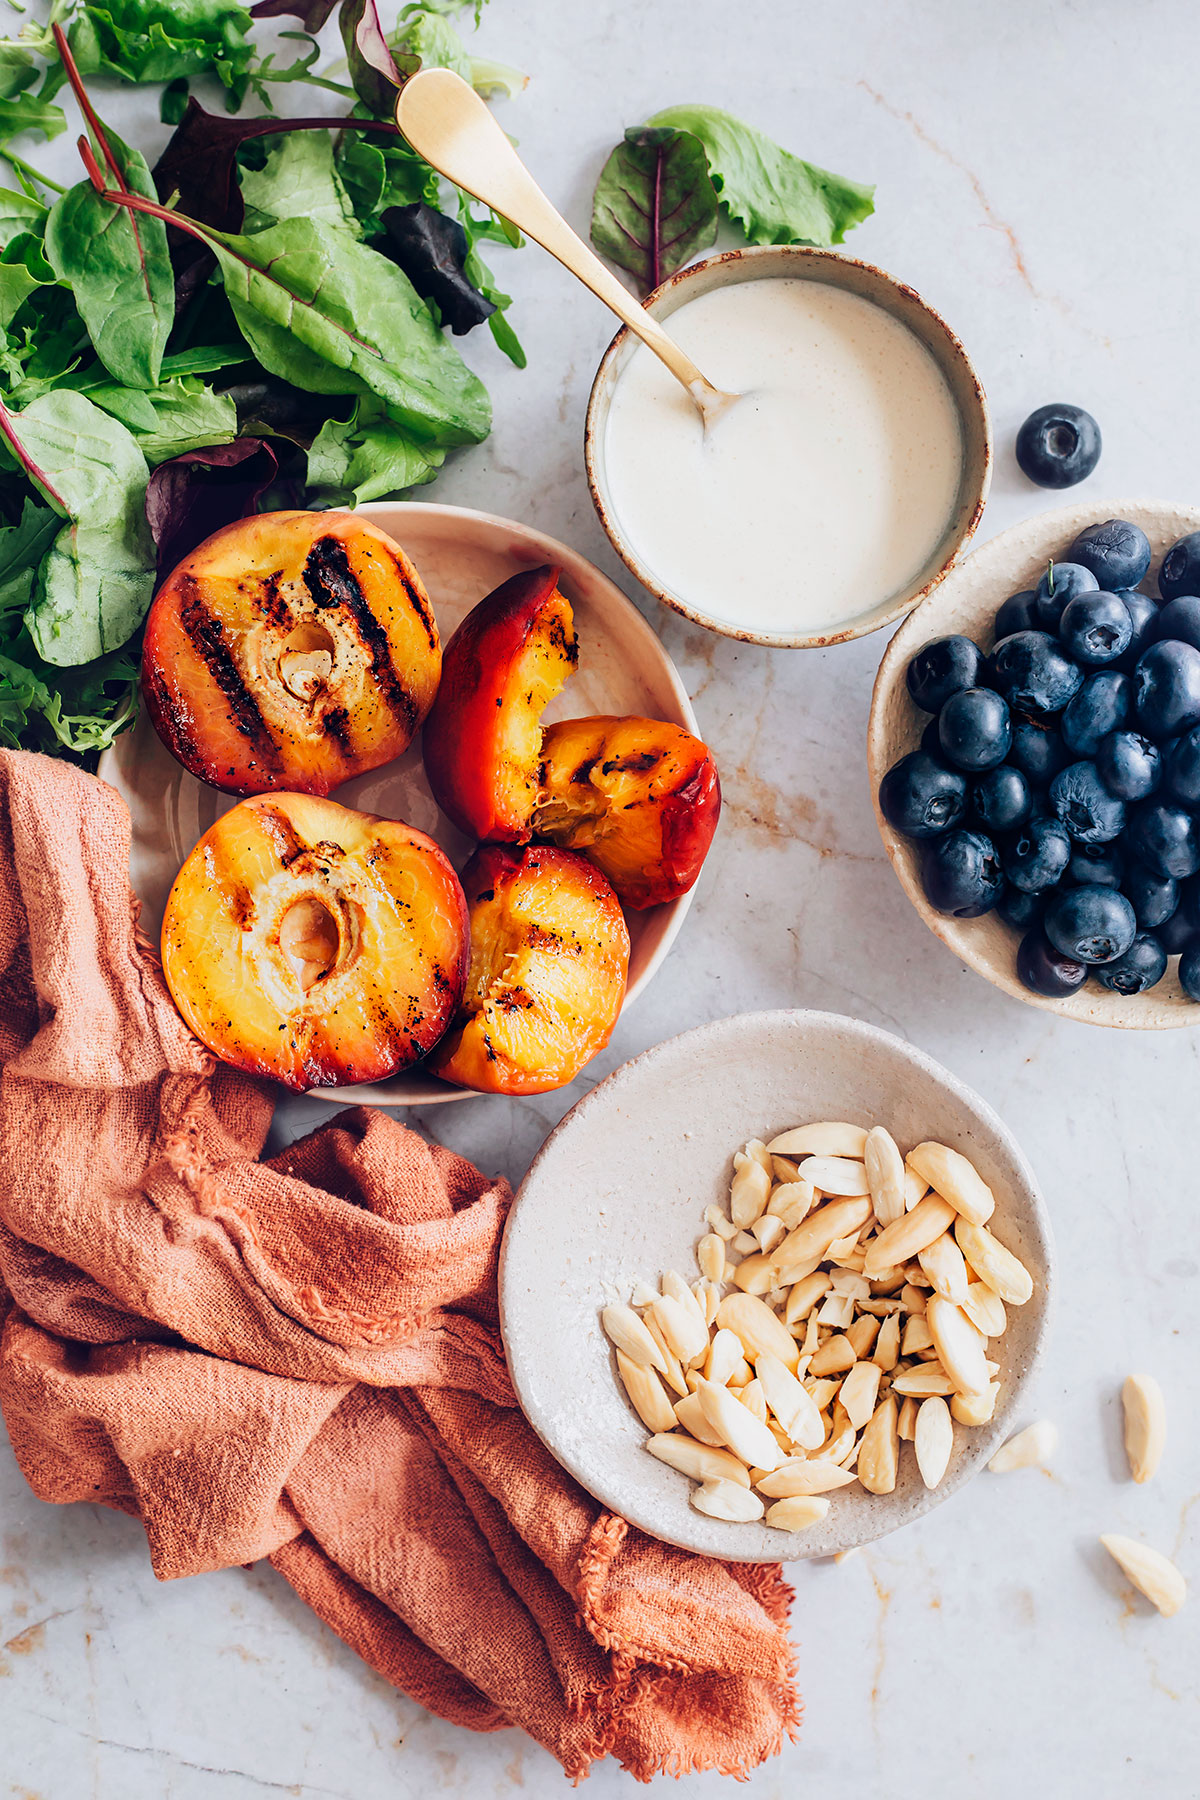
646,106,874,245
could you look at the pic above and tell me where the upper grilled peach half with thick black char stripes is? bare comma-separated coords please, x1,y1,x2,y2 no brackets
142,513,441,794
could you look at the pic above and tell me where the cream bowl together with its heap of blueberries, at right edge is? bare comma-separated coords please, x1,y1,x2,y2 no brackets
867,500,1200,1030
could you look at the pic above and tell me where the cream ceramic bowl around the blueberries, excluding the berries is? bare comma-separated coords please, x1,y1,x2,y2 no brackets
867,500,1200,1031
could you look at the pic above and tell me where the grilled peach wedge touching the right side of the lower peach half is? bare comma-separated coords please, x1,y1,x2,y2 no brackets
428,844,630,1094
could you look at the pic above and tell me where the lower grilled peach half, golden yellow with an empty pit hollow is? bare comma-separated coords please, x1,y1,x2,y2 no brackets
162,794,470,1089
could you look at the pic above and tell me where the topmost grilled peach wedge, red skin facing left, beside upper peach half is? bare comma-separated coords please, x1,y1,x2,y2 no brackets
421,565,578,842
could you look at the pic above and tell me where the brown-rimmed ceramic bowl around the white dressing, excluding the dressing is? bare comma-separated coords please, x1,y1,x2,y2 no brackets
583,245,991,650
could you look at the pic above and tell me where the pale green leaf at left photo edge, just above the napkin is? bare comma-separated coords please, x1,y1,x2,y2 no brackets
0,387,153,668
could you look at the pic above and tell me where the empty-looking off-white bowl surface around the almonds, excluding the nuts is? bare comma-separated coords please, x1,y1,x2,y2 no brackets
500,1012,1054,1562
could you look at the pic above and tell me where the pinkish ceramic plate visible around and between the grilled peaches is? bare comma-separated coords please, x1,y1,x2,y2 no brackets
99,500,696,1107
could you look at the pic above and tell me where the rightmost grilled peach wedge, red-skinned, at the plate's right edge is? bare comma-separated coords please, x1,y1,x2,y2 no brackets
533,718,721,911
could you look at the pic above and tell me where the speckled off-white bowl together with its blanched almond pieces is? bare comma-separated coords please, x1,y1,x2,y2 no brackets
500,1012,1052,1561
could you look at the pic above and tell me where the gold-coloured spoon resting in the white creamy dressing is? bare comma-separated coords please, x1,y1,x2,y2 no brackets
396,68,741,428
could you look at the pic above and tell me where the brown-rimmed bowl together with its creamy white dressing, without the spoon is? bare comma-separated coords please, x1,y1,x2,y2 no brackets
585,245,991,648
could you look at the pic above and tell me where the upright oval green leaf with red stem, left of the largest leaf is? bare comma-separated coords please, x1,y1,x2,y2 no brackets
45,128,175,387
